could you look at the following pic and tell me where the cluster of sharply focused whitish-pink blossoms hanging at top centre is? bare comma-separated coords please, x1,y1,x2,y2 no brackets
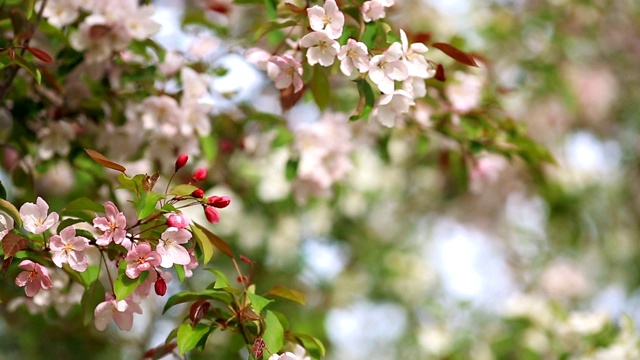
245,0,435,127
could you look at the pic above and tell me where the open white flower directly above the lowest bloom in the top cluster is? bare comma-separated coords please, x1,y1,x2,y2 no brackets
369,42,409,94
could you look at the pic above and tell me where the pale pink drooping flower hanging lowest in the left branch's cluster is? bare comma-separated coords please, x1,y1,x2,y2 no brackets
93,294,142,331
